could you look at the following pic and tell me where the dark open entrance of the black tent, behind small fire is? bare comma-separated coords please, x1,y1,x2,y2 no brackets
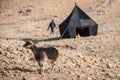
76,27,90,36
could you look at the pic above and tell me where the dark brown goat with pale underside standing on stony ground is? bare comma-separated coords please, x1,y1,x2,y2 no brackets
23,41,59,74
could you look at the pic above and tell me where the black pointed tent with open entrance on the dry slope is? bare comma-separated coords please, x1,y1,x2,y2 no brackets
59,5,98,38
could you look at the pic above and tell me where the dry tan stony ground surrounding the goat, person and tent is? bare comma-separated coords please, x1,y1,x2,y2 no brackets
0,0,120,80
